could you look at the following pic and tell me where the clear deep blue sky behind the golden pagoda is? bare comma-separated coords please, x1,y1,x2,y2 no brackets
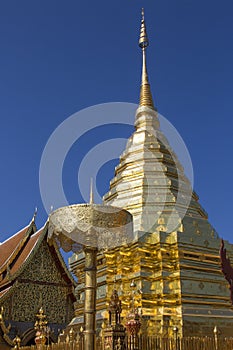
0,0,233,242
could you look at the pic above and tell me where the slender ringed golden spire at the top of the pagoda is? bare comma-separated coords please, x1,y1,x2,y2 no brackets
139,8,155,109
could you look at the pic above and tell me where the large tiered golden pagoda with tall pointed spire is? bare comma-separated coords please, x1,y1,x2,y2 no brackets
70,9,233,336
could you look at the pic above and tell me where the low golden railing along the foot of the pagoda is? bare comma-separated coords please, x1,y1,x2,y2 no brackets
20,336,233,350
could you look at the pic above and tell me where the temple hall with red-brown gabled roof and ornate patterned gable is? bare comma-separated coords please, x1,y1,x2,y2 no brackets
0,218,76,350
